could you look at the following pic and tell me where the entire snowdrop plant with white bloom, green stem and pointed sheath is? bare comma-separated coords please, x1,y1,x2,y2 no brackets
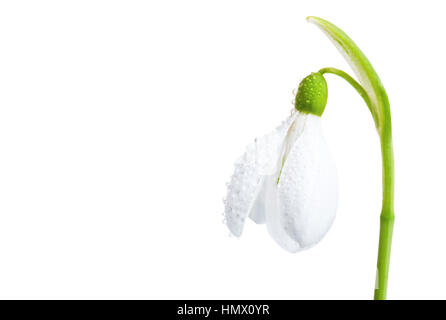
224,17,395,300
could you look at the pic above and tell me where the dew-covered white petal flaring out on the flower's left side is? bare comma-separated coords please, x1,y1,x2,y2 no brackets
225,112,298,237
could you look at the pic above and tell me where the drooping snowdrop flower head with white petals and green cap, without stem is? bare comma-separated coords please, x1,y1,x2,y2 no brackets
225,73,338,252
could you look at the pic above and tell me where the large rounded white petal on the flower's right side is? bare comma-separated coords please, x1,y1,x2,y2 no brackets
278,115,338,249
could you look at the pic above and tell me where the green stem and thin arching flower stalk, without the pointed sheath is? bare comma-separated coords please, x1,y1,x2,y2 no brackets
319,68,395,300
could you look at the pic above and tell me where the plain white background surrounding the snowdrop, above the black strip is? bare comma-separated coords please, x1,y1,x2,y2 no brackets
0,0,446,299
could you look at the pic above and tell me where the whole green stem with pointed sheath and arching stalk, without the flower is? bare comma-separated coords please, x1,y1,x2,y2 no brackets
307,17,394,300
